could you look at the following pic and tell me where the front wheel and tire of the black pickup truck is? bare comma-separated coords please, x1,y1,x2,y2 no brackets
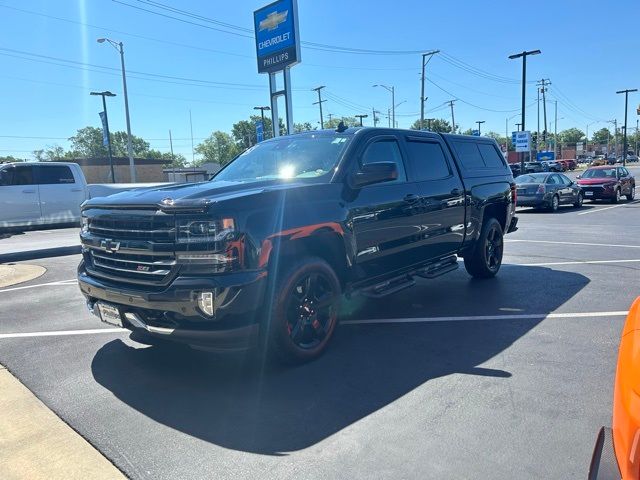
263,257,341,364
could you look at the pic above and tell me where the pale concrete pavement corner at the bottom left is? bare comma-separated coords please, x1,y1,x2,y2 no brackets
0,365,126,480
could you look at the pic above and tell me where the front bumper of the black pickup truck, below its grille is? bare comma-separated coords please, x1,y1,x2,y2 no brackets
78,264,267,351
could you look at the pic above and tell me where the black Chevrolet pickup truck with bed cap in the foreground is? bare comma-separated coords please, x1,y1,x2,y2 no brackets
78,128,517,362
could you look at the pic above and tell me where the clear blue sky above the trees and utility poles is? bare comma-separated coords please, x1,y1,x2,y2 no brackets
0,0,640,159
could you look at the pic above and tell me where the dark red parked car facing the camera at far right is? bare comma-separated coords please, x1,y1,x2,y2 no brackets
578,165,636,203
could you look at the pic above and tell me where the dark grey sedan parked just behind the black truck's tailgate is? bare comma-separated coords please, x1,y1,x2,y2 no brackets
516,173,584,212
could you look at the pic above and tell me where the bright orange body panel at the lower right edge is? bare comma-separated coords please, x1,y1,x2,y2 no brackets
613,297,640,480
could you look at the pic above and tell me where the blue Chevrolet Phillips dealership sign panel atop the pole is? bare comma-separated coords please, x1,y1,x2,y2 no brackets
253,0,300,73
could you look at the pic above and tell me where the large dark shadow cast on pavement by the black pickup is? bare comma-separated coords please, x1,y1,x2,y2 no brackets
91,265,589,455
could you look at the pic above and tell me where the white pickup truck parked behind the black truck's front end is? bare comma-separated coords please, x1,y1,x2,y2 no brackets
0,162,170,229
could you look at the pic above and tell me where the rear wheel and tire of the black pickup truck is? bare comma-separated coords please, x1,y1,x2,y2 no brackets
464,218,504,278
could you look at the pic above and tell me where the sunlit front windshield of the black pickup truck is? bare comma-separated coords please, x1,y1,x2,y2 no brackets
213,134,350,182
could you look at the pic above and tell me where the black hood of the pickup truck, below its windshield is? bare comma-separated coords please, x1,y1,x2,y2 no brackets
83,180,302,211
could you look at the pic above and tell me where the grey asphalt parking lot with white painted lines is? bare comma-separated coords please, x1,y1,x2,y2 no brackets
0,169,640,479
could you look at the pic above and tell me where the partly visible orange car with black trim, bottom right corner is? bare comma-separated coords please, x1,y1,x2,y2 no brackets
588,297,640,480
